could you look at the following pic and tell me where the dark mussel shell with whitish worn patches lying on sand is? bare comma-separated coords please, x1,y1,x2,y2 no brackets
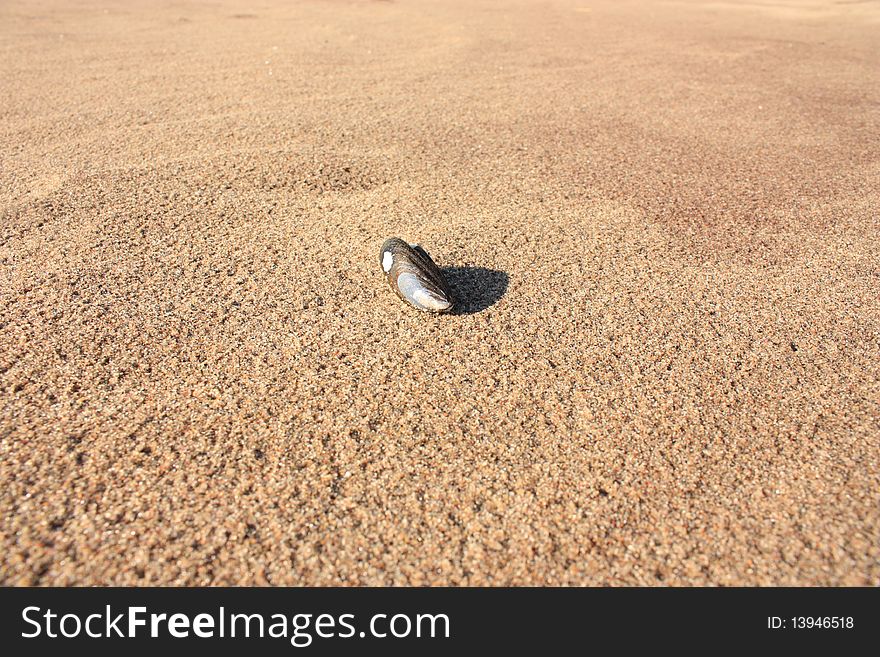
379,237,454,313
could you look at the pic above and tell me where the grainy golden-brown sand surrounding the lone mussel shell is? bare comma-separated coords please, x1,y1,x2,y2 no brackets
0,0,880,585
